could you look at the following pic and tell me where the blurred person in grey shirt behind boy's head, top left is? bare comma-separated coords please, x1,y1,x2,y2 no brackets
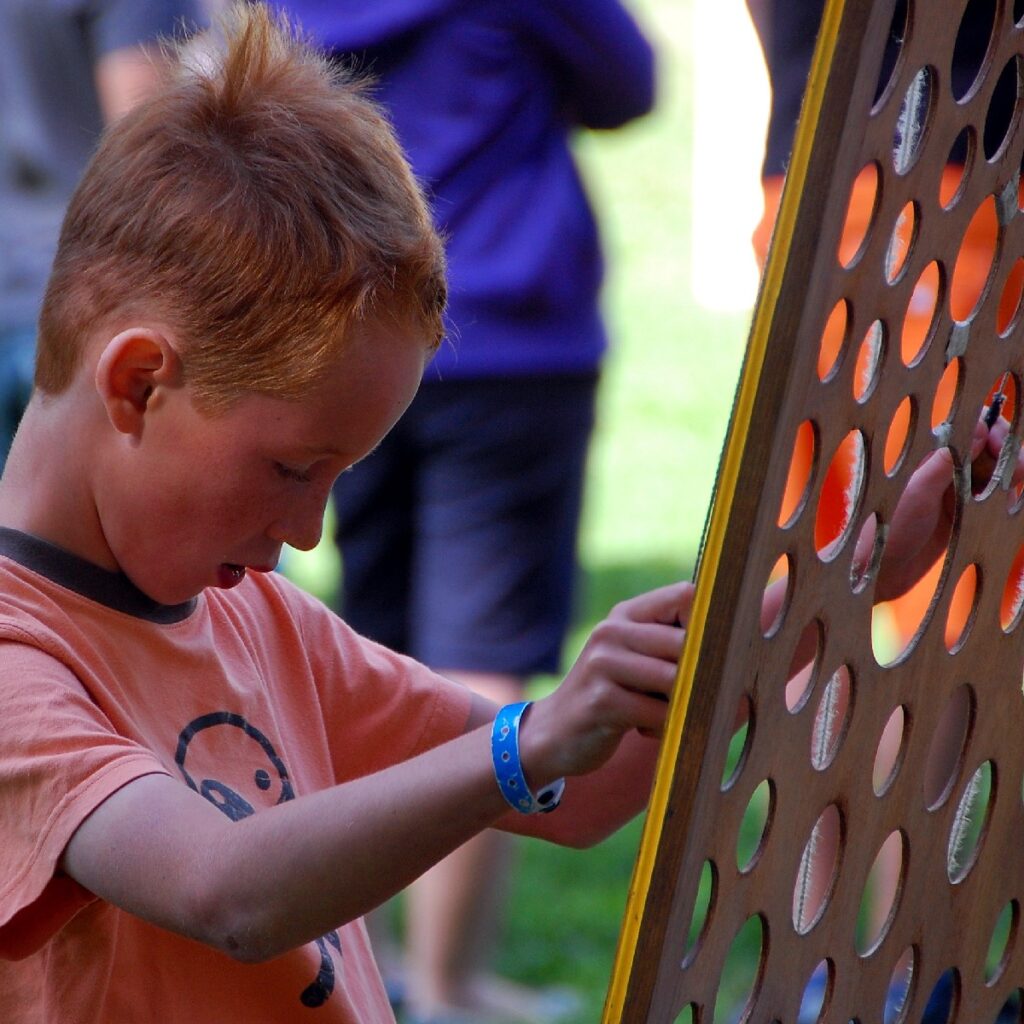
0,0,200,470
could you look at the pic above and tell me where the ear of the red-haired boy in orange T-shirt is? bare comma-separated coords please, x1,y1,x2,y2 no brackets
95,328,181,434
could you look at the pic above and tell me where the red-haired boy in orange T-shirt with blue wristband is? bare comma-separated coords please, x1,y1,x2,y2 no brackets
0,7,689,1024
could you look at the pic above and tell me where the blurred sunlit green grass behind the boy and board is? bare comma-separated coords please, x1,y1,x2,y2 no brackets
289,0,753,1024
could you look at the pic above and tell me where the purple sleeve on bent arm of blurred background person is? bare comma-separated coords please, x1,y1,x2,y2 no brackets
517,0,654,128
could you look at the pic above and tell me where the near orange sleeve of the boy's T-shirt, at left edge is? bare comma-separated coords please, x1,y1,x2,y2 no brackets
0,629,167,959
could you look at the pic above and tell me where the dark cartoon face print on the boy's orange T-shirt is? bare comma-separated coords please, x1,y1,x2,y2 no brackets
174,711,341,1008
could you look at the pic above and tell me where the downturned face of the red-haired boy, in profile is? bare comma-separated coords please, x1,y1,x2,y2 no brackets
98,325,428,604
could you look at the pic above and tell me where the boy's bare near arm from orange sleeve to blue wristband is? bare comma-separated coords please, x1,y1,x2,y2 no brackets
60,712,506,961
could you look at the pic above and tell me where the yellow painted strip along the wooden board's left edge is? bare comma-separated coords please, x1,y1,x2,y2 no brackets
601,0,845,1024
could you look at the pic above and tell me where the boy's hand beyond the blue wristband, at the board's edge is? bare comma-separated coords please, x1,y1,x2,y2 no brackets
520,583,693,786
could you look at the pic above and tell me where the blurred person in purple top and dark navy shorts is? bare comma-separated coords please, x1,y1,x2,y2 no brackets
266,0,654,1024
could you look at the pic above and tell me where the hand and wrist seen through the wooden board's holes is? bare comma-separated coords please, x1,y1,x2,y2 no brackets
872,411,1024,601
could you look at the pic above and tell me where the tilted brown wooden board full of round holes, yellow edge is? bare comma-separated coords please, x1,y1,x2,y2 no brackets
604,0,1024,1024
